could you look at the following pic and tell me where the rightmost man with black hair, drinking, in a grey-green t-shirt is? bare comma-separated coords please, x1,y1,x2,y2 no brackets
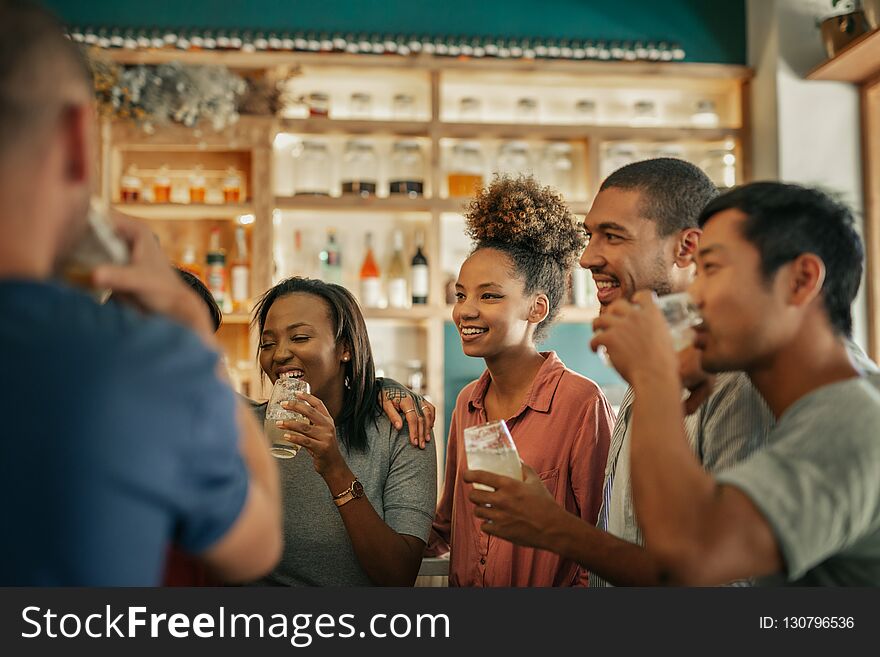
593,183,880,586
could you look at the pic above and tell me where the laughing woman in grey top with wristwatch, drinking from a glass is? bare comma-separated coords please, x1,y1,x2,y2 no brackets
255,278,437,586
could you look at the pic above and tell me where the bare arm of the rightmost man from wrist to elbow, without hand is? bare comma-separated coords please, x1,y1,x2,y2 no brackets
631,364,783,585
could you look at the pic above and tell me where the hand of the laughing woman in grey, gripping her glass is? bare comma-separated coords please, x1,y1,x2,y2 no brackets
278,393,351,482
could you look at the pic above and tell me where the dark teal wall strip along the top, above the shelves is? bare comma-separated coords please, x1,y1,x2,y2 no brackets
45,0,746,64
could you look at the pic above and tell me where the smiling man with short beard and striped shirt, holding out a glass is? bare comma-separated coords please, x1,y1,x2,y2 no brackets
465,158,873,586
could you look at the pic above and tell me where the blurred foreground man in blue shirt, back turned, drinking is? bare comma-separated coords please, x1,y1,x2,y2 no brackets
0,0,281,585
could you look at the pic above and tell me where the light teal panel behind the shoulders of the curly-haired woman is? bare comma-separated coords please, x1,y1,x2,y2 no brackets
443,322,626,440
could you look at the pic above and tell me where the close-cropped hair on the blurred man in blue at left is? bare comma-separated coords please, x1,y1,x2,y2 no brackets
0,0,92,160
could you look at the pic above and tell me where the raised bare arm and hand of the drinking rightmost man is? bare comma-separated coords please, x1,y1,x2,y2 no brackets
591,292,783,584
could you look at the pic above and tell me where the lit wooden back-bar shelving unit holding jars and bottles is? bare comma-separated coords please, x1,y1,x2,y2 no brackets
102,50,749,464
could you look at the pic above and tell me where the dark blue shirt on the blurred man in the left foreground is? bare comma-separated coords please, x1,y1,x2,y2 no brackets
0,280,248,586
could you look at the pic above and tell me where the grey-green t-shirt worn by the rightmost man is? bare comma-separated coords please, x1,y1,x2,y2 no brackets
716,374,880,586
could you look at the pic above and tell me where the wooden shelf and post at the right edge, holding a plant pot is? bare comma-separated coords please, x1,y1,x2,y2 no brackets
807,30,880,361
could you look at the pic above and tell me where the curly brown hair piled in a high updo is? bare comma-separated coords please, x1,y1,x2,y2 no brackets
465,175,586,342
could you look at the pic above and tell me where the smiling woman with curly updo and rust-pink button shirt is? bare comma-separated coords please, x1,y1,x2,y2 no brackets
428,177,614,586
